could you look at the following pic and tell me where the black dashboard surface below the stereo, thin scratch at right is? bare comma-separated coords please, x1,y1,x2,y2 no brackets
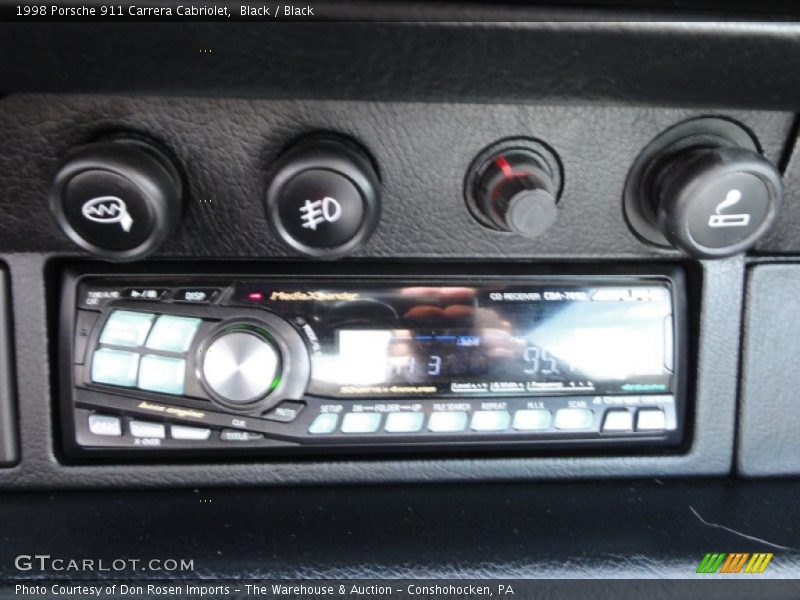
0,480,800,580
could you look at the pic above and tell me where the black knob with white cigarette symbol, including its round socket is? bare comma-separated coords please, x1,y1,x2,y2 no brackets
625,118,783,258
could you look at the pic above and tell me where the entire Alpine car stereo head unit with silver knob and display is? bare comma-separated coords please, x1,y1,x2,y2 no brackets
62,270,685,456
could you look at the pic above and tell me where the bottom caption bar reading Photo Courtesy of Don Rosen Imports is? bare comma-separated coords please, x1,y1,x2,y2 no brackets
7,577,800,600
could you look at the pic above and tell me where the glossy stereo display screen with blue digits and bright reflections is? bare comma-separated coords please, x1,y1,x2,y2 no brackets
247,281,673,398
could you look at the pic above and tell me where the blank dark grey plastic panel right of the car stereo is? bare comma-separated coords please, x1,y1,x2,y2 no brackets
737,264,800,476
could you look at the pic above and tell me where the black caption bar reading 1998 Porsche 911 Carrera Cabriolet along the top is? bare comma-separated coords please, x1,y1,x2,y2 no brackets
0,0,800,23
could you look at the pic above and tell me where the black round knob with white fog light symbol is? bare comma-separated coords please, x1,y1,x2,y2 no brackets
266,136,380,258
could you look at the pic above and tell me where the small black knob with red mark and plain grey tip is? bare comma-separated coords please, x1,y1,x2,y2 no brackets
467,140,560,238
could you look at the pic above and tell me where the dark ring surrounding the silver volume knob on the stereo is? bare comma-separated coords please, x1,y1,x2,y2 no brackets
194,312,311,414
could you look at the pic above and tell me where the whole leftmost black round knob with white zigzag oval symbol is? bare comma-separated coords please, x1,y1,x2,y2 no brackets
50,138,183,261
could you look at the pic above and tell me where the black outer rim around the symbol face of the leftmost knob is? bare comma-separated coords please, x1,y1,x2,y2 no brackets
49,136,183,262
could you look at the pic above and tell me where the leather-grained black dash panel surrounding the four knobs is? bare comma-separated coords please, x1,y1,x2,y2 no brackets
0,96,791,260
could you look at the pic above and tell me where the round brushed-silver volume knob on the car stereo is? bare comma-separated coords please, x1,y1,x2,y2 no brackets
202,330,280,404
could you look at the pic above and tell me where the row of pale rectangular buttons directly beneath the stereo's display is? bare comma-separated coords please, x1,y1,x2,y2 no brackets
308,408,667,435
